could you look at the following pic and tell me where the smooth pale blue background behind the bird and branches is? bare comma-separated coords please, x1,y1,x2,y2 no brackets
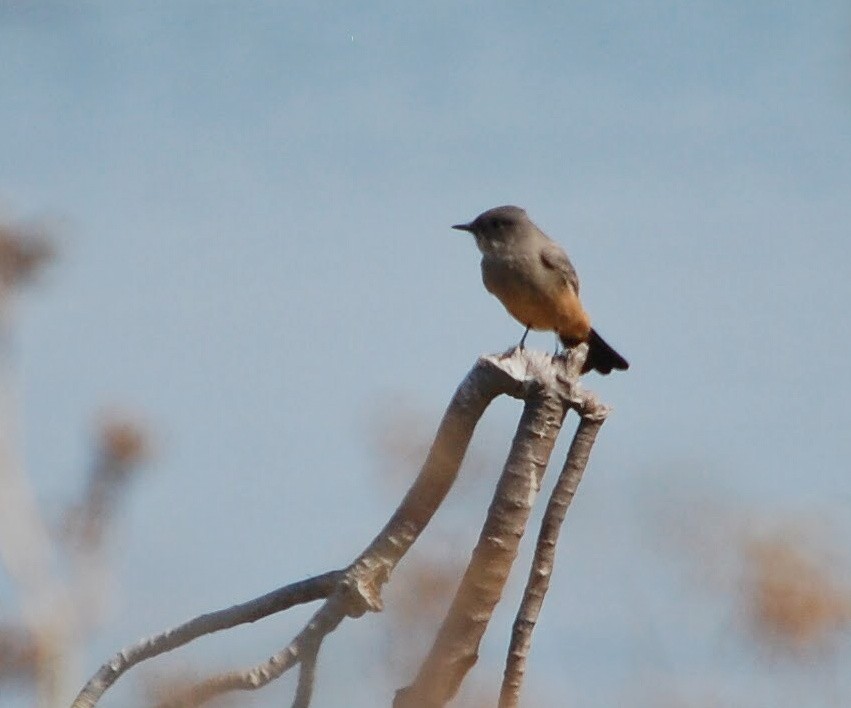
0,0,851,708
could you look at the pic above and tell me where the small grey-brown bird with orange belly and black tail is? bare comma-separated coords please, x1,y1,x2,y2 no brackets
452,206,629,374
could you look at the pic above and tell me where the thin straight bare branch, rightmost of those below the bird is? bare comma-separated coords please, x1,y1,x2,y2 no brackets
499,406,607,708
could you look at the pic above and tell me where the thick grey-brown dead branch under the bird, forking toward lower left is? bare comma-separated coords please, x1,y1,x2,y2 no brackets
72,346,605,708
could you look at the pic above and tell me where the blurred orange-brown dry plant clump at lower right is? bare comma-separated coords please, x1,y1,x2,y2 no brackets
666,493,851,661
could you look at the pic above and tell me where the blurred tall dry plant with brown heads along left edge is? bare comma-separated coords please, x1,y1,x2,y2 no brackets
0,222,150,708
